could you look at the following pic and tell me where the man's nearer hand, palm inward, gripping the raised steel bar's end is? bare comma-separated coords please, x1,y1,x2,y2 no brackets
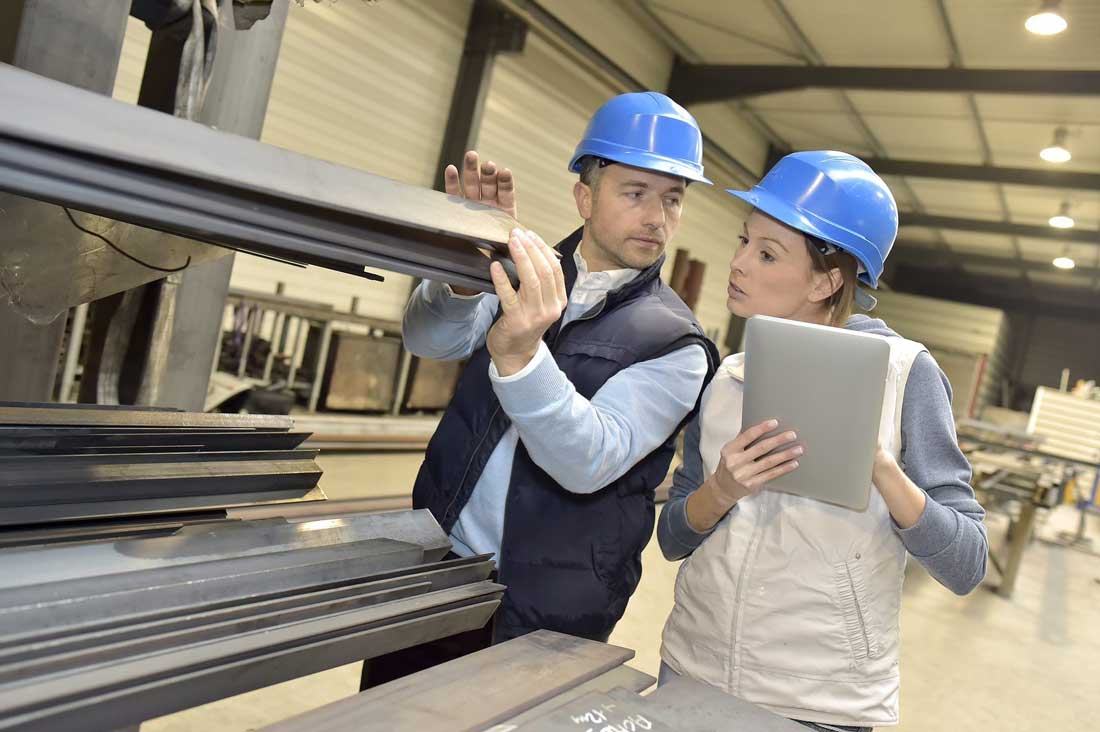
485,229,569,376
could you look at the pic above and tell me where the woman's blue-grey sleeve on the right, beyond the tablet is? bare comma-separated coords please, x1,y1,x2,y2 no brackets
894,353,989,594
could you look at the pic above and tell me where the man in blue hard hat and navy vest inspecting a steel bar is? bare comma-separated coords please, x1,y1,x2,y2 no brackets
364,92,718,686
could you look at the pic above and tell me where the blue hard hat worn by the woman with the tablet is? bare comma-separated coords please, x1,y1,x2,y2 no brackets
726,150,898,287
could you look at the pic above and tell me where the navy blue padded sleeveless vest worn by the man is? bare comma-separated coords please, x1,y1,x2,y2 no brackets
413,230,718,641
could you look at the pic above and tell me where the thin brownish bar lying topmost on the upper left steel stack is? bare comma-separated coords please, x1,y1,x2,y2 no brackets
0,406,294,431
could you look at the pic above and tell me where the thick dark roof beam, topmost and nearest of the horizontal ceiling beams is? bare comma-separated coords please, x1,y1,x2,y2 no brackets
669,63,1100,105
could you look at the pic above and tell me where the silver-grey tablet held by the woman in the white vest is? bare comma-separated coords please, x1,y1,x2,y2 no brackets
741,316,890,511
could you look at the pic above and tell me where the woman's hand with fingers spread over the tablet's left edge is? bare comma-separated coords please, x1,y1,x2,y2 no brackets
686,419,804,533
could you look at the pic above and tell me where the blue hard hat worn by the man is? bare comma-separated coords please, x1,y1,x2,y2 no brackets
569,91,711,185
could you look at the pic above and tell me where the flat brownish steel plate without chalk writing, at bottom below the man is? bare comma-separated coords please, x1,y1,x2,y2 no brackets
258,631,634,732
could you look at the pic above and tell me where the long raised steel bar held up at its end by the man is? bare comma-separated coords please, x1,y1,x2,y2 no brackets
0,67,516,295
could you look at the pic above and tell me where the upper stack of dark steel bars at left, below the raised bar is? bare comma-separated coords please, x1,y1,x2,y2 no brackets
0,403,325,546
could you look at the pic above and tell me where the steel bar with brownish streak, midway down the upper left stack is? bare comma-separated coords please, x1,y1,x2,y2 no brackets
0,450,321,506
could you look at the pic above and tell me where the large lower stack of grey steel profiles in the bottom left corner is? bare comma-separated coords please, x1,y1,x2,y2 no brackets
0,511,504,732
